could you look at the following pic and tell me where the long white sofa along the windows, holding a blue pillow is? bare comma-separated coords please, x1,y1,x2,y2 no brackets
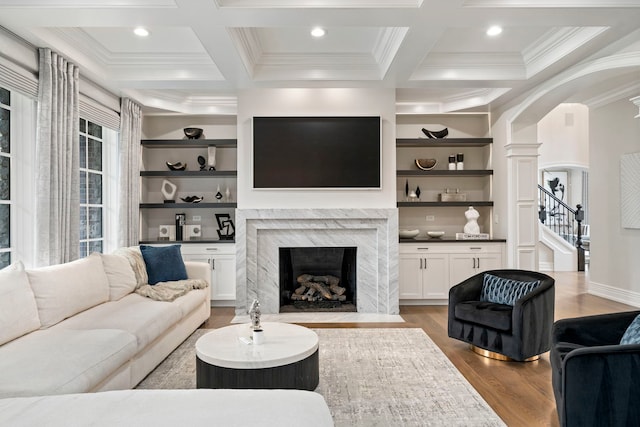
0,254,211,398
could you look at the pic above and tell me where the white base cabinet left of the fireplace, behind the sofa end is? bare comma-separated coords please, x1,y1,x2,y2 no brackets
182,243,236,301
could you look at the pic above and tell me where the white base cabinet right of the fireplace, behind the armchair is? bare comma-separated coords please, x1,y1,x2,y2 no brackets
399,241,504,303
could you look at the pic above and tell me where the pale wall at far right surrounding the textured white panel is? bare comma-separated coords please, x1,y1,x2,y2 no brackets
589,99,640,305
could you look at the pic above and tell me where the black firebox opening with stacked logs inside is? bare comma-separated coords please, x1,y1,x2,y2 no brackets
278,247,357,313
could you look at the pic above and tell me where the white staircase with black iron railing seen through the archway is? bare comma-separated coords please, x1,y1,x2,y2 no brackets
538,185,585,271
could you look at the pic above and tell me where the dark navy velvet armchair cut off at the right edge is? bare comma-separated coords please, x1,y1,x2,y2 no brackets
550,311,640,427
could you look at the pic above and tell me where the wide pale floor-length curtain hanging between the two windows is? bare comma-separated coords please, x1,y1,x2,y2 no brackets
36,48,80,266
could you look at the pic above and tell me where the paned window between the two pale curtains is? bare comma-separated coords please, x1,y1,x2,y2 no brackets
79,119,105,257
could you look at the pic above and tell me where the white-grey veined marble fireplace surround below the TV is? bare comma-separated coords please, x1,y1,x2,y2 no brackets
236,209,399,315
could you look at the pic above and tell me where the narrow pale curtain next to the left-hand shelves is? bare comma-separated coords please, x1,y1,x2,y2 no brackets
118,98,142,247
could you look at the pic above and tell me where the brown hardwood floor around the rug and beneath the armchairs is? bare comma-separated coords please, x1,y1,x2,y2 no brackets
203,272,636,427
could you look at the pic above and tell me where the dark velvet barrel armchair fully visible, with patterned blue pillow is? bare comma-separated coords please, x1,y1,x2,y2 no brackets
448,270,555,361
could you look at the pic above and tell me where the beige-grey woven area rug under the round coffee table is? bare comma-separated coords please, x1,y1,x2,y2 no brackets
138,328,505,427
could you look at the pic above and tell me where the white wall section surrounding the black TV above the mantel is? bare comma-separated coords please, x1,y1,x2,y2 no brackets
238,88,396,209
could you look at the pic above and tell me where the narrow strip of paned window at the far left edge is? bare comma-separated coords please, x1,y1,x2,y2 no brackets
0,88,11,268
